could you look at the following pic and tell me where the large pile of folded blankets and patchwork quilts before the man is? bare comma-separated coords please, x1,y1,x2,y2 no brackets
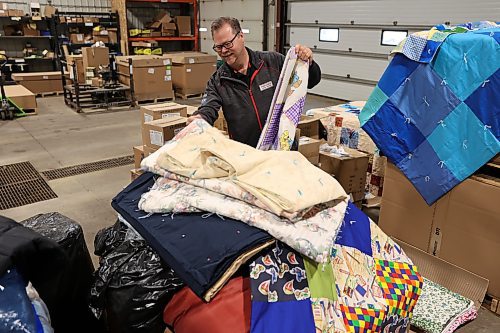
131,116,423,332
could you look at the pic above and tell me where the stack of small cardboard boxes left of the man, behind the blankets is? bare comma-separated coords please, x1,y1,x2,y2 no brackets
130,102,188,180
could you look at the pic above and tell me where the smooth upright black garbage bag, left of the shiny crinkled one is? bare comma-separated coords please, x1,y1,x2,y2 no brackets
21,212,103,333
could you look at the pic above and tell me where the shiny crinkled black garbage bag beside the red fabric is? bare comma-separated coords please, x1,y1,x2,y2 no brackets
90,221,184,333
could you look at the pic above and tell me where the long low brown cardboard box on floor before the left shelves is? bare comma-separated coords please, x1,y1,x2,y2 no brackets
12,72,63,94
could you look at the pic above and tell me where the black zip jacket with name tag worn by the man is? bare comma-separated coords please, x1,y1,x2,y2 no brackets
195,48,321,147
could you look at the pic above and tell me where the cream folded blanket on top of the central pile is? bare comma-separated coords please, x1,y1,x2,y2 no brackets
142,119,347,215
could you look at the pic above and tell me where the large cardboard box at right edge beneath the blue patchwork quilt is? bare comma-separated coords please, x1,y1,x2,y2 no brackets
379,163,500,298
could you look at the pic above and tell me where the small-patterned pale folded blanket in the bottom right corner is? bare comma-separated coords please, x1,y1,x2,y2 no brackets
411,278,477,333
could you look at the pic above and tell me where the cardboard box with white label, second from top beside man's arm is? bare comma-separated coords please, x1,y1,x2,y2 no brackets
142,117,187,149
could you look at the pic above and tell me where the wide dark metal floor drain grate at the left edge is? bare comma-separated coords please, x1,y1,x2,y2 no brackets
0,162,57,210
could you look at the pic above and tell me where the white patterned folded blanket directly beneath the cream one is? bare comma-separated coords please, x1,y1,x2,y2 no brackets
139,178,347,262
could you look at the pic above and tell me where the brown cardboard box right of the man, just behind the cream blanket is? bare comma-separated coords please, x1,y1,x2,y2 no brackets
320,147,368,201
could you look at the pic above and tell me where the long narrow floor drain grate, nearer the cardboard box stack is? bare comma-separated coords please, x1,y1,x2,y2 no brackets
42,155,134,180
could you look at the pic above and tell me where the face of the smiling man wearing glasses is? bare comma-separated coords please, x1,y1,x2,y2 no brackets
213,24,245,66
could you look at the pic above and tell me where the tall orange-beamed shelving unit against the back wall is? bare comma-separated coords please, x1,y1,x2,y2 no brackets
111,0,199,54
